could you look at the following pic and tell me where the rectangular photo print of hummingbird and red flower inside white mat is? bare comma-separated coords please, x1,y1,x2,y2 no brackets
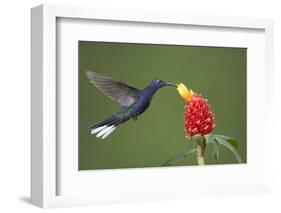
78,41,247,170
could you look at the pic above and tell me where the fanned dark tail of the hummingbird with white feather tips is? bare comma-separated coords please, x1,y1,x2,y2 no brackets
89,115,130,139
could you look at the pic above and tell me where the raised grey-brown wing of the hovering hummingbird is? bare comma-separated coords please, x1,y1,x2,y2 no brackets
86,71,139,107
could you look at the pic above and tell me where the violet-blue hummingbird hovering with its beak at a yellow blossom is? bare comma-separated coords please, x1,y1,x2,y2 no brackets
86,71,177,139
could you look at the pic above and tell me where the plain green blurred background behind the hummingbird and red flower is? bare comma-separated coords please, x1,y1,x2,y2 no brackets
78,41,247,170
